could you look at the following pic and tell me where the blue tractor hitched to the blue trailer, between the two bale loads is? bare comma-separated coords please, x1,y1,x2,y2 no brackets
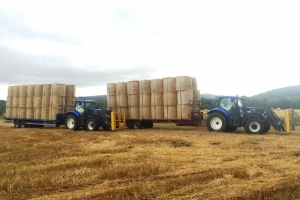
65,100,111,131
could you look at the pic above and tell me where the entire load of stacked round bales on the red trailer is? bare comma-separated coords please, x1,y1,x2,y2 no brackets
107,76,200,120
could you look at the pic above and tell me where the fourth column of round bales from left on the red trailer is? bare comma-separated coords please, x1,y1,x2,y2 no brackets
139,80,151,119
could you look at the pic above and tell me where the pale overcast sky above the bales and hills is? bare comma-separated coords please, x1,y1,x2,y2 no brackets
0,0,300,100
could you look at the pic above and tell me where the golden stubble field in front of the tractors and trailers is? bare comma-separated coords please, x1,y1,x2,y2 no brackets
0,121,300,200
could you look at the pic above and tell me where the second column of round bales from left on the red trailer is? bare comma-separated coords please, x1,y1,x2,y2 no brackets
116,82,129,119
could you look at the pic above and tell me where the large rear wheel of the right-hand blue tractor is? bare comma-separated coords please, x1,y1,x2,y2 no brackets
206,113,227,132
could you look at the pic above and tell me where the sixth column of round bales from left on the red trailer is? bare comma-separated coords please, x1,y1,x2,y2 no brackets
163,77,177,119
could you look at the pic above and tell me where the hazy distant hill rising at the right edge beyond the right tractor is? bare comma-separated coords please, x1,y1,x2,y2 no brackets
253,85,300,98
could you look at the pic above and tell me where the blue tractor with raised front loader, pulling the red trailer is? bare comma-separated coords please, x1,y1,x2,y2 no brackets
206,96,284,134
